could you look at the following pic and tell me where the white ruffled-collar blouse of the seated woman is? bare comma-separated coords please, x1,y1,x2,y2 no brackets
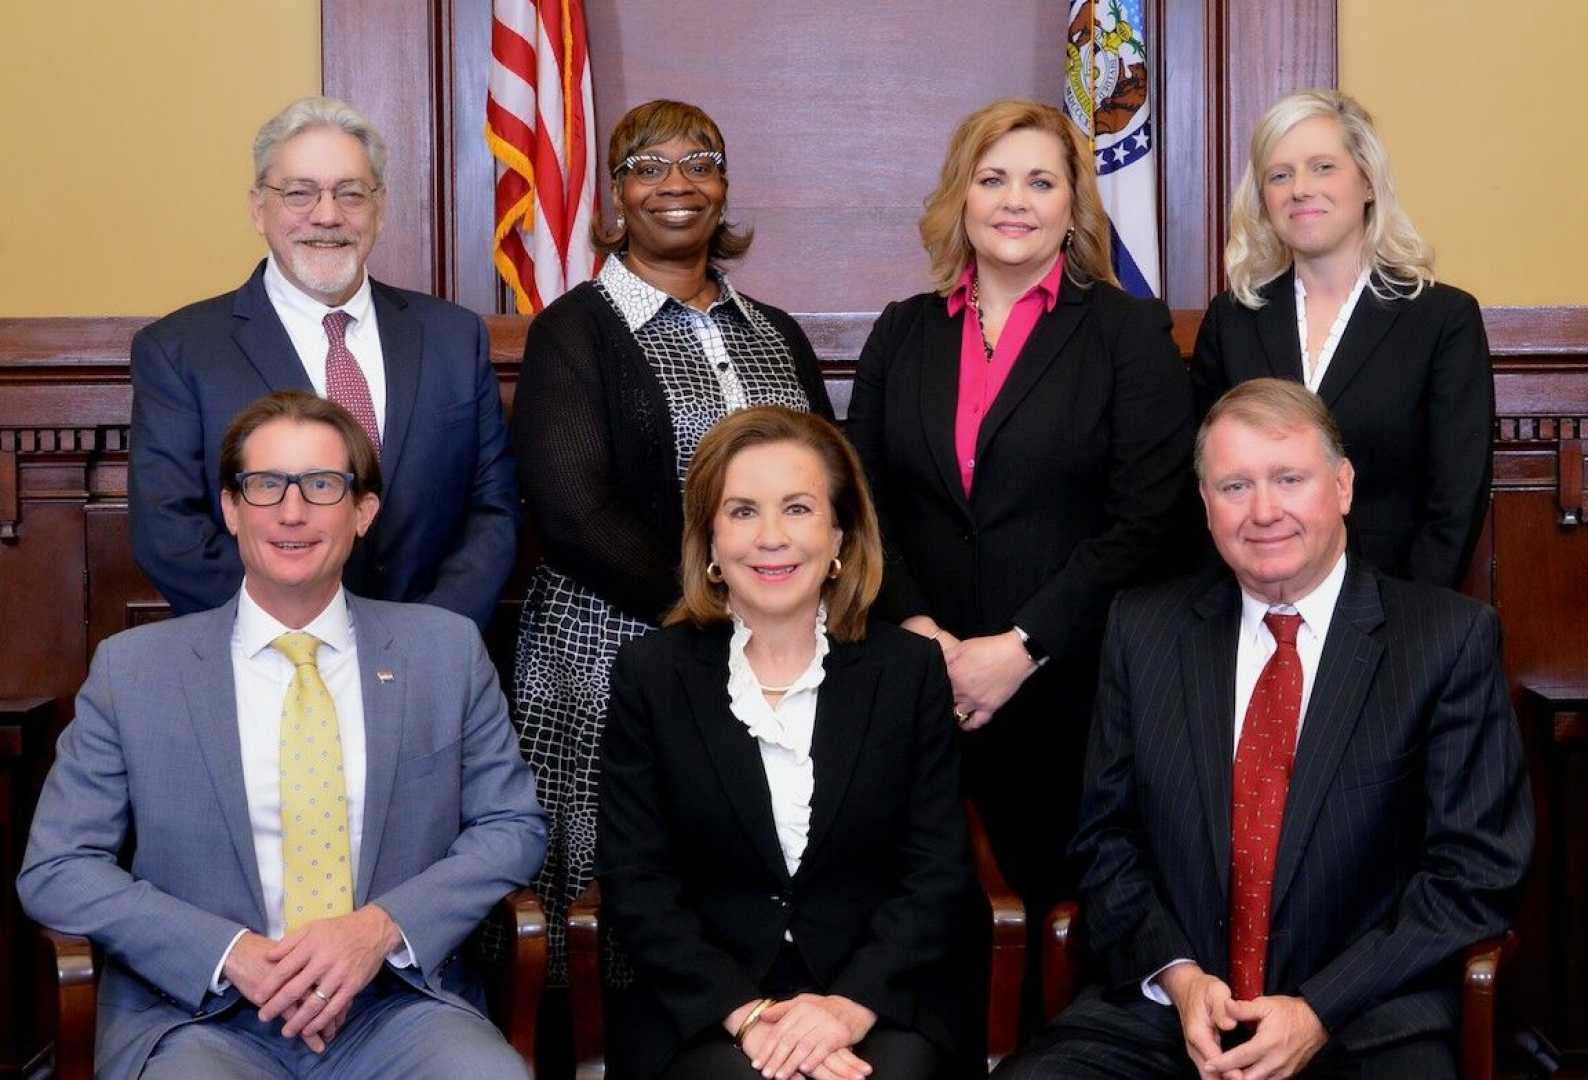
727,605,831,940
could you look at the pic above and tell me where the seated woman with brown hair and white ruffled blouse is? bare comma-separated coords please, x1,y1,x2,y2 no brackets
597,407,985,1080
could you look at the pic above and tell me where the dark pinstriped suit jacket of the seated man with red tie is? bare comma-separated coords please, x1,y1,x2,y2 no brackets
1073,561,1532,1050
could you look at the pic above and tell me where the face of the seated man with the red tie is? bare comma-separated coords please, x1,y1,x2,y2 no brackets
1201,418,1353,604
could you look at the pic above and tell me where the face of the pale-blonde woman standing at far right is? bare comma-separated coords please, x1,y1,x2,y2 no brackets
1262,116,1372,259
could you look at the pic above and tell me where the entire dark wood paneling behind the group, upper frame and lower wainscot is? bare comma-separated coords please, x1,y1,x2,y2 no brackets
0,0,1588,1067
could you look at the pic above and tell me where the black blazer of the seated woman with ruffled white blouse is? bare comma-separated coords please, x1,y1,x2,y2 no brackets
596,624,986,1077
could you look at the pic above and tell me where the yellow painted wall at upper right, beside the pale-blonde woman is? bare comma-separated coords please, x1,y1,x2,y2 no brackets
1339,0,1588,305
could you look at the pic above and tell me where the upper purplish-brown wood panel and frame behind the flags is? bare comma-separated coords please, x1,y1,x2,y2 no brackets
324,0,1336,313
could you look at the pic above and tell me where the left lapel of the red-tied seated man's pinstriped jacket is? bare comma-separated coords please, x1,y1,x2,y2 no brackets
1180,578,1240,902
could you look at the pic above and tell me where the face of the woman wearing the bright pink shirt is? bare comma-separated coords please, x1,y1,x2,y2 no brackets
966,127,1072,273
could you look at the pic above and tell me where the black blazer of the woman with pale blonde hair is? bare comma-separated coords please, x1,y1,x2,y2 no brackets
1191,270,1494,588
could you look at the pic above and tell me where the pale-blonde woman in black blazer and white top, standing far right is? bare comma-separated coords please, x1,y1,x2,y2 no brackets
1191,91,1494,588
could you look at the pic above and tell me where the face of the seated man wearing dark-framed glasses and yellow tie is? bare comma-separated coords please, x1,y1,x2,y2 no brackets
221,419,380,626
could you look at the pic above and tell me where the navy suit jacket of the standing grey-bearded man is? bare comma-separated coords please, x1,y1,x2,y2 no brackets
129,262,519,627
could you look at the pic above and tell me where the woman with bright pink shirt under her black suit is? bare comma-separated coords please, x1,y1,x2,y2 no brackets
848,100,1191,924
